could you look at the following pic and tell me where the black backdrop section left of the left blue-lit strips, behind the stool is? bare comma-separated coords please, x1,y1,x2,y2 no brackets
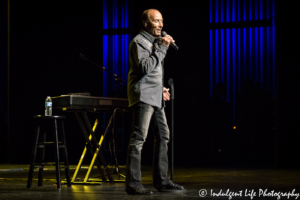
8,1,102,164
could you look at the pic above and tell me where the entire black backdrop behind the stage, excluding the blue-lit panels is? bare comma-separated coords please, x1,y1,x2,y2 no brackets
0,0,300,168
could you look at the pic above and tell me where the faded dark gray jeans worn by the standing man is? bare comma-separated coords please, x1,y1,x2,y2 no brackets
126,102,170,190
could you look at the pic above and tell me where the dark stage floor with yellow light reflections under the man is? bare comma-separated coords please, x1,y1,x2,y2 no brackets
0,165,300,200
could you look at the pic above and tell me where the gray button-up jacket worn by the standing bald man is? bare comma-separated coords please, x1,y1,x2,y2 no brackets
127,30,168,108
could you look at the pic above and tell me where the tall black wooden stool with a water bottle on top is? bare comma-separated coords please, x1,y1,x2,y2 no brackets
27,115,71,188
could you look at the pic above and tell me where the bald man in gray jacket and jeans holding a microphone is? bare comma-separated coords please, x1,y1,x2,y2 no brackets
126,9,184,194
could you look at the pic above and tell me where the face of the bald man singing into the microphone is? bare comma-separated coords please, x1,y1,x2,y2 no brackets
144,10,163,37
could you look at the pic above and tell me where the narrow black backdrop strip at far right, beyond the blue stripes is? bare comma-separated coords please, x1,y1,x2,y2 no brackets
276,2,300,168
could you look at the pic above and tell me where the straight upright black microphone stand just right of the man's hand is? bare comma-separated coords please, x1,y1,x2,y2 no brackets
168,78,174,181
